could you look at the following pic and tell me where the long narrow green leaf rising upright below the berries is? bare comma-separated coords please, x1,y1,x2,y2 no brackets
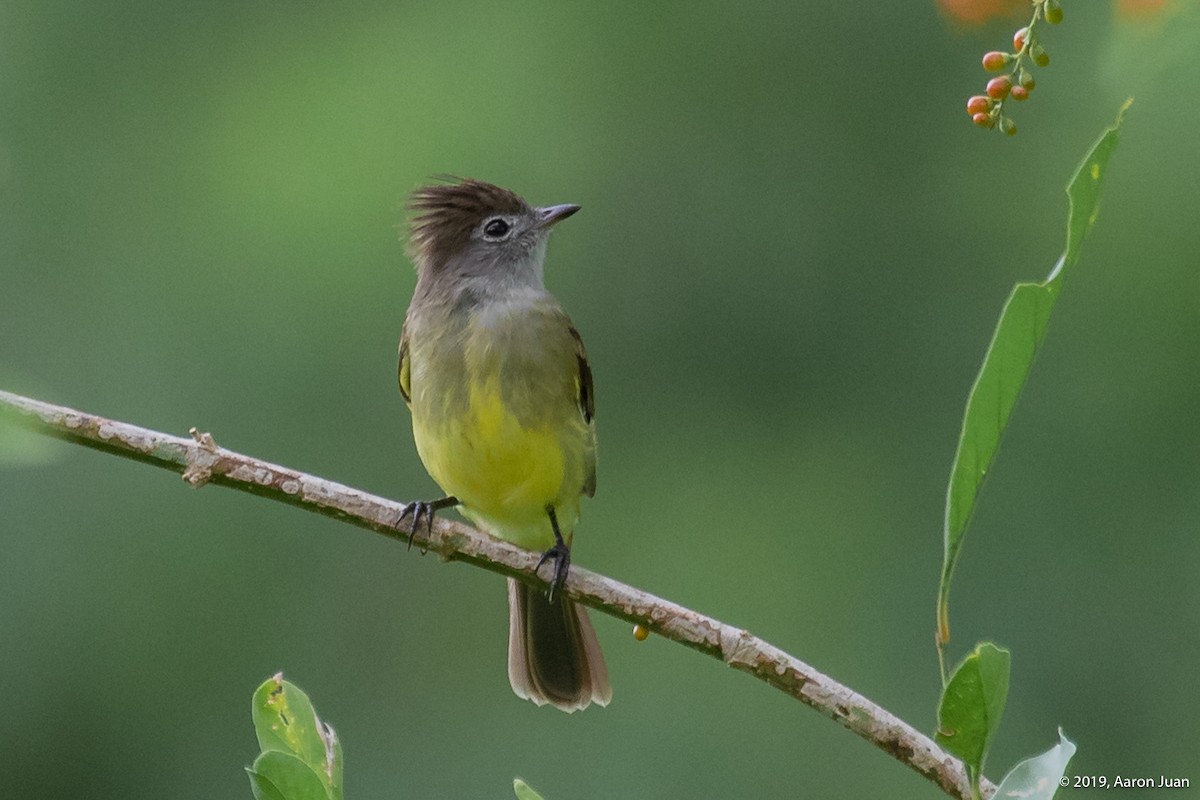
937,102,1129,644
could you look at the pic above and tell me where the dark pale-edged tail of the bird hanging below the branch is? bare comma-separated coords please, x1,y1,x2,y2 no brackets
509,578,612,712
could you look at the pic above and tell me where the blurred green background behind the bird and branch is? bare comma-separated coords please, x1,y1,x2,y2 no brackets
0,0,1200,800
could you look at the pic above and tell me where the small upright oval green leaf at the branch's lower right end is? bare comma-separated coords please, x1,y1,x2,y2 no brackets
937,642,1012,775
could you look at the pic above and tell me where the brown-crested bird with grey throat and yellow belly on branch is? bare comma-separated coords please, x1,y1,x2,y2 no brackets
400,180,612,711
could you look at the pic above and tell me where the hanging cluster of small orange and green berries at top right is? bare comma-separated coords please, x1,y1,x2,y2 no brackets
967,0,1062,136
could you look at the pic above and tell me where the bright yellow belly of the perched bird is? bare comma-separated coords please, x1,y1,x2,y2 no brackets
413,378,578,549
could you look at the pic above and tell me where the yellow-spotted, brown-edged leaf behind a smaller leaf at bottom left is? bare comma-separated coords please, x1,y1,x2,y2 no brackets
251,673,342,800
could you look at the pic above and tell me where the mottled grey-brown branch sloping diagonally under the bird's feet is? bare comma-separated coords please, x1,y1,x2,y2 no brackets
0,391,996,799
